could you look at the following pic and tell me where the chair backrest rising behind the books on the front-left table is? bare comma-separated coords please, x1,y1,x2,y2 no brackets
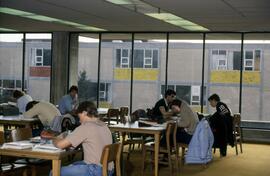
11,128,32,141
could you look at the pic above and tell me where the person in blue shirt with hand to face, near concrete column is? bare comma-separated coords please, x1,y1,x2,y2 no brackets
58,85,79,115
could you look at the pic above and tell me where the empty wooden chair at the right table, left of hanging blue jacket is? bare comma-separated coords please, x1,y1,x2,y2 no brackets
142,122,179,175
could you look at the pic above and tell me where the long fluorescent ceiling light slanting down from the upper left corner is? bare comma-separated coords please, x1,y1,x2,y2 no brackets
0,7,105,31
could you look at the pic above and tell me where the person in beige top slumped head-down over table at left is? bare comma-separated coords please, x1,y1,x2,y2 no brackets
23,101,61,127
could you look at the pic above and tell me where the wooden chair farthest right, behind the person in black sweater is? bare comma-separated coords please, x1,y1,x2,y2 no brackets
233,113,243,155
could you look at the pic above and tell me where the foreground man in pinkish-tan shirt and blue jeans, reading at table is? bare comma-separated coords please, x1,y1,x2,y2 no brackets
53,101,113,176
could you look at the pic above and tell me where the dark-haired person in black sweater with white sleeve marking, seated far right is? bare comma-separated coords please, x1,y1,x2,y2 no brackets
208,94,234,156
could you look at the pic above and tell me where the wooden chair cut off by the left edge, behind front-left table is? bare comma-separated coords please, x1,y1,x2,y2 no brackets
0,131,28,176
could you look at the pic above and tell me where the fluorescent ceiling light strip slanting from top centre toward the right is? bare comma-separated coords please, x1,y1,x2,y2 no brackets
105,0,209,31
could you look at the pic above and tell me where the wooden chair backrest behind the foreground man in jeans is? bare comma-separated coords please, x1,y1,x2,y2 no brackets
100,143,121,176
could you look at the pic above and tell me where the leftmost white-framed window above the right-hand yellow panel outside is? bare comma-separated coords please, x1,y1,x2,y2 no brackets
212,50,227,70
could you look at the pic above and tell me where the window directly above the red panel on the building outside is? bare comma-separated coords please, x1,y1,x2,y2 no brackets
34,48,51,67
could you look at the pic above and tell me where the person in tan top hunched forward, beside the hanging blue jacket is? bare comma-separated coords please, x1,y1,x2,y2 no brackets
160,99,199,146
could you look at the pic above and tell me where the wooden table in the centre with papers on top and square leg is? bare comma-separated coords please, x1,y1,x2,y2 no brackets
109,122,166,176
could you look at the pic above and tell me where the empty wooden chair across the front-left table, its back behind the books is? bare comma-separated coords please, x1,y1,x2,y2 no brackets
11,128,50,176
